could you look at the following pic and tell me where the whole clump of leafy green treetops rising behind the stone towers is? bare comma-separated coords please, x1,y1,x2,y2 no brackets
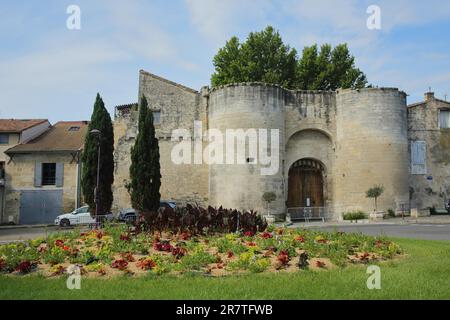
211,26,367,90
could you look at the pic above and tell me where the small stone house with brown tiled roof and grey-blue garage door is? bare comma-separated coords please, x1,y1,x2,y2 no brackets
2,121,88,224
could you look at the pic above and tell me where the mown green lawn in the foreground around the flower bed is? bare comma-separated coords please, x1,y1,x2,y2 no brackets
0,239,450,299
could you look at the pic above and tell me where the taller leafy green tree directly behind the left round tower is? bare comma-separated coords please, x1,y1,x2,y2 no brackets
211,26,297,88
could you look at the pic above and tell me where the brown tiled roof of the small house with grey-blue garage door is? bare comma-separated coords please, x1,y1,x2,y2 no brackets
5,121,89,154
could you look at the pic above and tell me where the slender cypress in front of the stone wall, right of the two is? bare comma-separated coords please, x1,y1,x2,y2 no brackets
127,96,161,214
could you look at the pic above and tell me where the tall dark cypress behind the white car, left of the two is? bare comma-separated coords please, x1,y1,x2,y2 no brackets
81,94,114,215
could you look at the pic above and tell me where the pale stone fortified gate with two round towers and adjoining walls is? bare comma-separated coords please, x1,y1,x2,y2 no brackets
114,71,449,219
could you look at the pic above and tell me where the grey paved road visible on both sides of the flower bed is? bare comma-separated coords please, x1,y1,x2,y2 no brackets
0,224,450,243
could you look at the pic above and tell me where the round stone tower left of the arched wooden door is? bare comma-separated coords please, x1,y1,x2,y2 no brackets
208,84,285,214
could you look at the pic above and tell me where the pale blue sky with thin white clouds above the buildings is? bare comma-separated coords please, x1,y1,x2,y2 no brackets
0,0,450,123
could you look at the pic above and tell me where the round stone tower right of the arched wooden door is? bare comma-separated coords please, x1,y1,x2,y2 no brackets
333,88,409,215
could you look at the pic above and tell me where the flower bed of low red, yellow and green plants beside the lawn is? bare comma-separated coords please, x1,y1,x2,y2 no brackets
0,225,402,278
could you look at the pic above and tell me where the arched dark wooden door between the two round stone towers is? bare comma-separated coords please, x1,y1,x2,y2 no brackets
287,159,325,208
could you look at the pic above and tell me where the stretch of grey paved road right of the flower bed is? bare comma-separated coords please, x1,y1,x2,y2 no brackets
302,224,450,241
